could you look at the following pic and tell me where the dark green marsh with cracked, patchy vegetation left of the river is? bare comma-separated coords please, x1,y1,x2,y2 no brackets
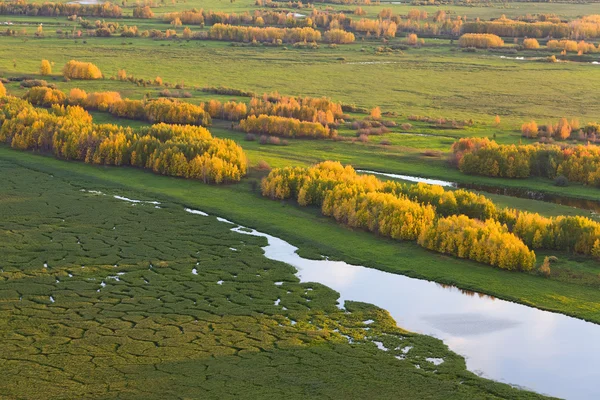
0,150,552,399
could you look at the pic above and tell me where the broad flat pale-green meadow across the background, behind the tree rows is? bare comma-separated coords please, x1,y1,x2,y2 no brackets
0,37,600,126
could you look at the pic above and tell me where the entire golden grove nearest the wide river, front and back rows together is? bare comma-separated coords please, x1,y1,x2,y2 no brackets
262,161,600,270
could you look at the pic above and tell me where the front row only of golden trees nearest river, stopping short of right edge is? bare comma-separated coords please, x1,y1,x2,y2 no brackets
262,161,535,271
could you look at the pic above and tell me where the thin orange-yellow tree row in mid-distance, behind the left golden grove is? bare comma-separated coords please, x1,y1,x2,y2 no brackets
24,86,343,138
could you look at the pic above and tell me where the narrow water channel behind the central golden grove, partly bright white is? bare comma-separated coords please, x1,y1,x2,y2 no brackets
356,170,600,214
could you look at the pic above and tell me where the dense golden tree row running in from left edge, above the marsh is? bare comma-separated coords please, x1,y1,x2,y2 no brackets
0,96,247,183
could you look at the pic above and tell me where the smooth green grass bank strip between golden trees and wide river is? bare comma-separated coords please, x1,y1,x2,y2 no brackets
0,148,600,328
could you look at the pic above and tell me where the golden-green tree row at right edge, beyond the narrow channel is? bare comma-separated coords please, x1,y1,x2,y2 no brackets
452,138,600,187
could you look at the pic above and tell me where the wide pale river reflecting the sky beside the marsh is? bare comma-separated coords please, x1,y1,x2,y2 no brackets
232,227,600,399
